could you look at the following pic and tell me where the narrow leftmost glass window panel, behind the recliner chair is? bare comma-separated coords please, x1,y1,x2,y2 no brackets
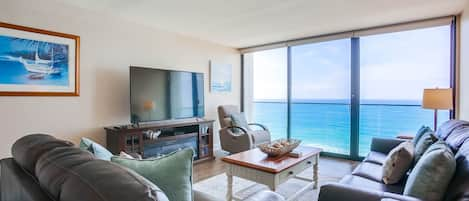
243,48,288,139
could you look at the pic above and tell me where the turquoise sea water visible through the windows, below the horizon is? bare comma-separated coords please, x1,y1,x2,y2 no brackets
252,102,449,156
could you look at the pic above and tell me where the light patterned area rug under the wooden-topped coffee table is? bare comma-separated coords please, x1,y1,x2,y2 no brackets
194,168,340,201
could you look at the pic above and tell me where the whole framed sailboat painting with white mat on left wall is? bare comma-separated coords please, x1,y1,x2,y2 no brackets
0,22,80,96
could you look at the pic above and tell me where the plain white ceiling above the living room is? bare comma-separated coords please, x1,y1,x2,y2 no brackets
57,0,467,48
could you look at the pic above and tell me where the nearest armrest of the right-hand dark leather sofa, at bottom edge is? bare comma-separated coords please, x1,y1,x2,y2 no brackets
318,183,422,201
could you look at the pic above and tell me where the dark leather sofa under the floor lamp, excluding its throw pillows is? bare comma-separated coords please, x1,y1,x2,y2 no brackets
319,120,469,201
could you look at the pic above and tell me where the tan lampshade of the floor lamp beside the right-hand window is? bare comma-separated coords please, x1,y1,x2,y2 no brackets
422,88,453,110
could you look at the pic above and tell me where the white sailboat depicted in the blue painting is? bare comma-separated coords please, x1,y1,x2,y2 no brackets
19,45,61,75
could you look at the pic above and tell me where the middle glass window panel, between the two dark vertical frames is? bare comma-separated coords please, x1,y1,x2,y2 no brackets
290,39,350,155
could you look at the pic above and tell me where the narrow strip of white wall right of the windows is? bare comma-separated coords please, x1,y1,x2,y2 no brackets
459,3,469,120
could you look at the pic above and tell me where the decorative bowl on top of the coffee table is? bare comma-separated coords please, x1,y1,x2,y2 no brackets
259,139,301,157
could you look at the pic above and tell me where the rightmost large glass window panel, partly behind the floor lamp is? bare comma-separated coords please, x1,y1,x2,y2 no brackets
359,25,451,156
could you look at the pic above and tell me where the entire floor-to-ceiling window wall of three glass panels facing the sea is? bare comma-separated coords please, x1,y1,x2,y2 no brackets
243,18,456,159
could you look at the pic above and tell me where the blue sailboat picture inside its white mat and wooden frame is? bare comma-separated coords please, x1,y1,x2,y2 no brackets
0,35,68,87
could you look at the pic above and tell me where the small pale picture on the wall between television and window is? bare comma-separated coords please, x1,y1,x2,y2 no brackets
210,61,232,92
